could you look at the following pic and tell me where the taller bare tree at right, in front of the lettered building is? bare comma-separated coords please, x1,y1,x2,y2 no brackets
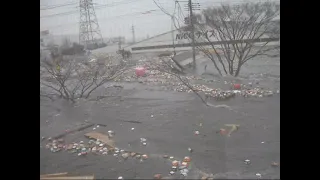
195,2,280,76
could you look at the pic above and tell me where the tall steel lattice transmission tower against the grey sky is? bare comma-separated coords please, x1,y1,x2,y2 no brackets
79,0,103,49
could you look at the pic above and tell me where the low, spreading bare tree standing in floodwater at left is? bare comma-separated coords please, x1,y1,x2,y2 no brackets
40,54,125,102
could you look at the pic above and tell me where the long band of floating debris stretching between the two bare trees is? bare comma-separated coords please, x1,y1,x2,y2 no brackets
115,57,278,100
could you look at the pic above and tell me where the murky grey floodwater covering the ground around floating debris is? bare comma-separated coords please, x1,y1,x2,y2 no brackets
40,52,280,179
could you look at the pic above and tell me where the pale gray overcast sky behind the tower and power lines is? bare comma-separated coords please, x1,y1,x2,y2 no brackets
40,0,270,38
